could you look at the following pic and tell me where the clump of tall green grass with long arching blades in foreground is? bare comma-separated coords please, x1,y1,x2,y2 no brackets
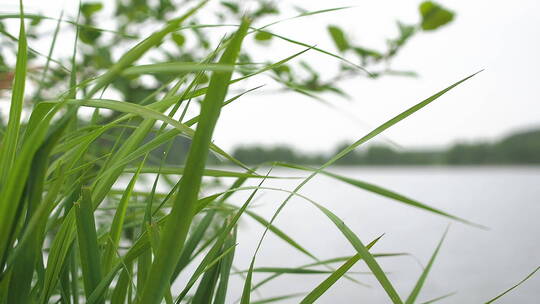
0,1,532,304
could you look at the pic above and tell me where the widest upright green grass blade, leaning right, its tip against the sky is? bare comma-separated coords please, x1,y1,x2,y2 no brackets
140,17,249,304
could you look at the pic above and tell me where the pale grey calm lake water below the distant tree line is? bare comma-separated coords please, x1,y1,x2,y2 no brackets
212,167,540,304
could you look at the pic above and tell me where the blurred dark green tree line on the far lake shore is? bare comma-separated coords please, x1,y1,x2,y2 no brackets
233,130,540,166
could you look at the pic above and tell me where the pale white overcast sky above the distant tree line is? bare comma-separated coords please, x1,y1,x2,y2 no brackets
4,0,540,151
